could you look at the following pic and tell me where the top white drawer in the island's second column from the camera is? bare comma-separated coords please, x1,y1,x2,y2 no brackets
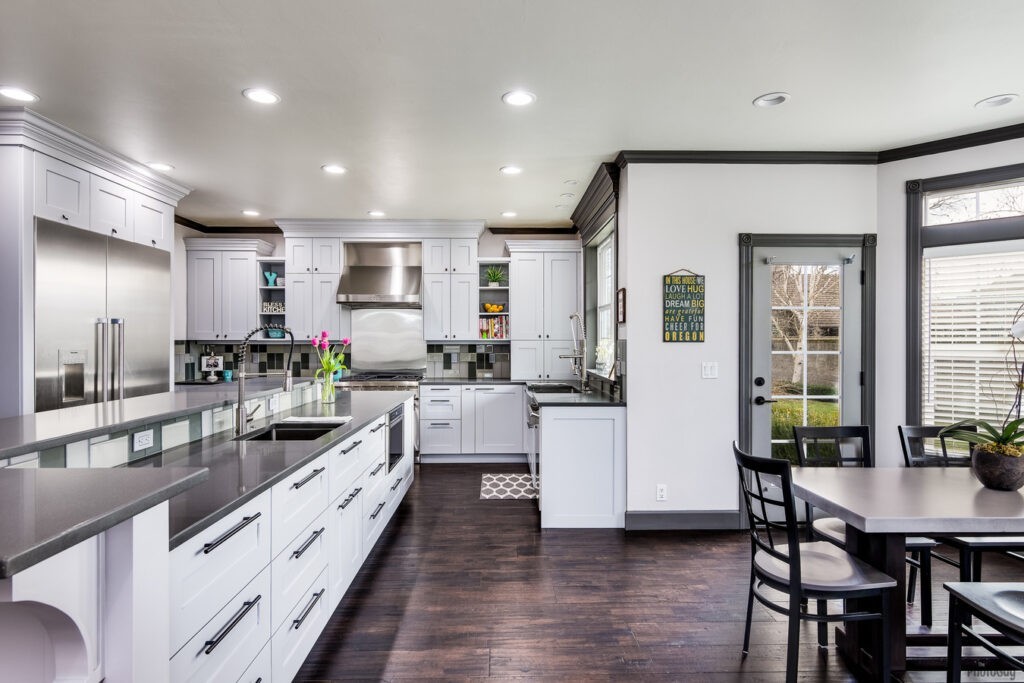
270,455,328,557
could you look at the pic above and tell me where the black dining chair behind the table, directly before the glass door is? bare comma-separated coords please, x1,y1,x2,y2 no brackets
793,425,938,630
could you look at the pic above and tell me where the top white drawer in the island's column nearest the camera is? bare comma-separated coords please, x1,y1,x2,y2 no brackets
170,492,270,653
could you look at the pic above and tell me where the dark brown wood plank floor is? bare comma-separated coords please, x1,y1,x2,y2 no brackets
296,465,1021,682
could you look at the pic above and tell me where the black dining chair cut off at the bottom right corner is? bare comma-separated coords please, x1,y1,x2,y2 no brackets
943,582,1024,683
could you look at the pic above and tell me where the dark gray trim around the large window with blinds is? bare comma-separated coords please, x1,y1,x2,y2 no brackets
905,164,1024,425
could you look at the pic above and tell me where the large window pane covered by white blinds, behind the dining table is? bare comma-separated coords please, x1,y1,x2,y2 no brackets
921,242,1024,425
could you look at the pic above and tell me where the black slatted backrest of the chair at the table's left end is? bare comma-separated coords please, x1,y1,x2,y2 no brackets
732,441,800,585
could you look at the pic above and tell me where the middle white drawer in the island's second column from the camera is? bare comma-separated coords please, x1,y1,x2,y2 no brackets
270,510,331,631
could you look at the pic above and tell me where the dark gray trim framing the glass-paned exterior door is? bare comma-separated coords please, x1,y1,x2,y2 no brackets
737,232,879,453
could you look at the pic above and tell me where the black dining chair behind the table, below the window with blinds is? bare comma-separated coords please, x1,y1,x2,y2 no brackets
897,425,1024,585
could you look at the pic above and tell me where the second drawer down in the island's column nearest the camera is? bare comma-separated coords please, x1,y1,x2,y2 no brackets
171,567,270,683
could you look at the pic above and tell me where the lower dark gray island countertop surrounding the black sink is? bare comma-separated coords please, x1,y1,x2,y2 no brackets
129,391,413,550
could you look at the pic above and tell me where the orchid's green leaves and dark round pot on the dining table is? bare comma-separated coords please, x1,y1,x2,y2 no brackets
939,419,1024,490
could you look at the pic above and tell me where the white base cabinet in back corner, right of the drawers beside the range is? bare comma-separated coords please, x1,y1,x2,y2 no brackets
462,384,525,454
